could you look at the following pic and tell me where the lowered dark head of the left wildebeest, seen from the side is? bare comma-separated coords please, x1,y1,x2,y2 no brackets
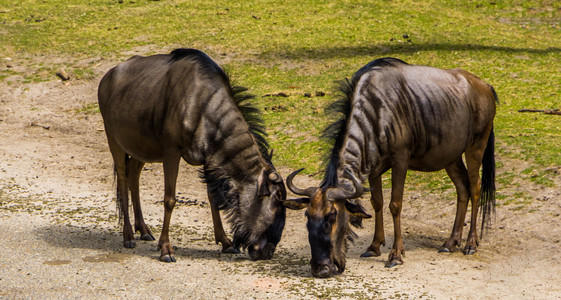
229,162,286,260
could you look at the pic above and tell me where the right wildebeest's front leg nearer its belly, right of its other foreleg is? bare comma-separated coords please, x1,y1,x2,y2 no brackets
386,163,407,268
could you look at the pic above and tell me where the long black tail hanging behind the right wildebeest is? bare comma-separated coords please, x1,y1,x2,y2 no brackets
479,129,496,238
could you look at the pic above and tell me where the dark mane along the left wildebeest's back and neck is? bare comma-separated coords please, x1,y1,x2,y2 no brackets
170,49,270,162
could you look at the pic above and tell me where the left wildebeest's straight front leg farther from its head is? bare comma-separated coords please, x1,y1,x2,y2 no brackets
158,155,180,262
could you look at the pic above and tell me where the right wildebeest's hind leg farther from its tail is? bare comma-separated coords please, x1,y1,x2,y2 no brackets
438,156,469,252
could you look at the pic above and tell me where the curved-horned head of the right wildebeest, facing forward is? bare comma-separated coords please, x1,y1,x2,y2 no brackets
284,169,371,277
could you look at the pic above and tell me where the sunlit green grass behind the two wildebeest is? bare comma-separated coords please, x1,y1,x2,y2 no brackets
0,0,561,187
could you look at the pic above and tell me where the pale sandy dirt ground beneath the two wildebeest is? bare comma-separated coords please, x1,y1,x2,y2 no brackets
0,55,561,299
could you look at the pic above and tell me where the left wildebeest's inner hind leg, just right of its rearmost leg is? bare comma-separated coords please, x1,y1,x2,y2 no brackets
126,157,155,241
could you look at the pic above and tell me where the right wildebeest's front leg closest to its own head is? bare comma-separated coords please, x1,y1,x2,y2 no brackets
361,176,386,257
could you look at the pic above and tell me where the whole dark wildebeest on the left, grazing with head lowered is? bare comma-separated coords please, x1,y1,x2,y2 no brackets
98,49,286,262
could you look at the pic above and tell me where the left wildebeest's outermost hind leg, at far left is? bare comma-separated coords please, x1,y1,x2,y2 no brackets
107,134,136,248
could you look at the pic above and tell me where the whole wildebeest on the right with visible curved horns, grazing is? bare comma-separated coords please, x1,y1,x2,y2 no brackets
285,58,497,277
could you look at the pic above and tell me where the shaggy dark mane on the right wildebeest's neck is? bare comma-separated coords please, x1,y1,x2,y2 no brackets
320,57,407,189
